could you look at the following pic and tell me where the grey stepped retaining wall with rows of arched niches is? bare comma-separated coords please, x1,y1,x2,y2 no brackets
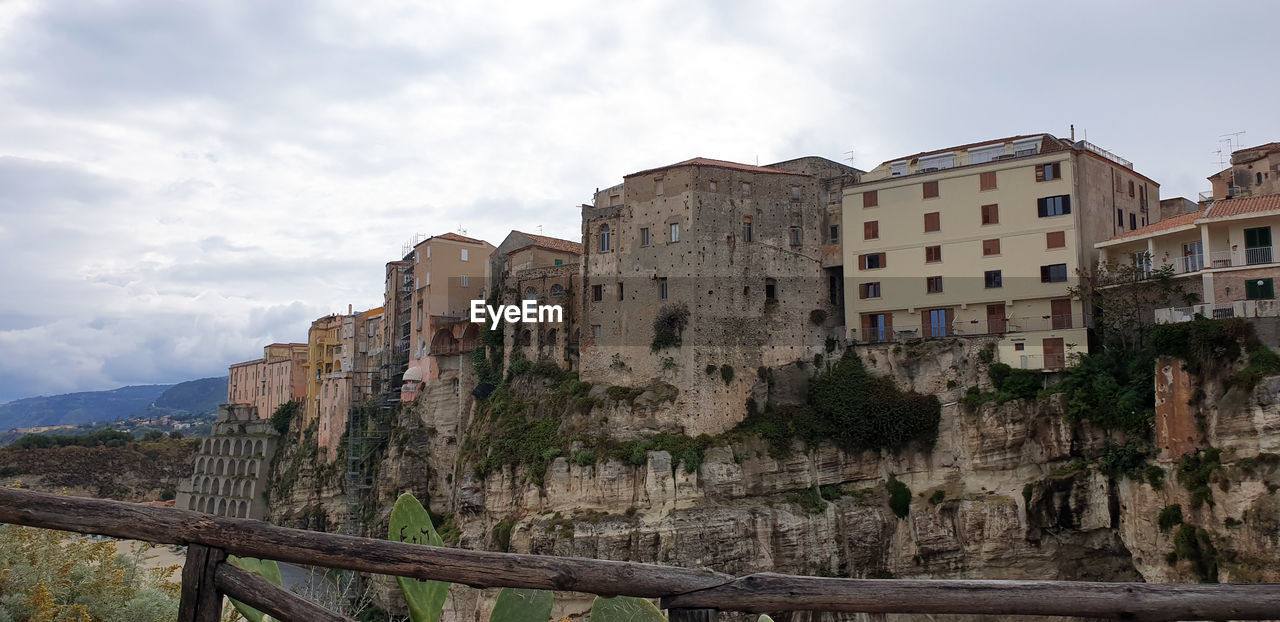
174,404,278,520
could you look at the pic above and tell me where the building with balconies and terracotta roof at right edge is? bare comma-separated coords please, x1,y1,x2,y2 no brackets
1096,195,1280,323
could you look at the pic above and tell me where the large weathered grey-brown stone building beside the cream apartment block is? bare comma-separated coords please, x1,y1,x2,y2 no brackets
579,157,860,434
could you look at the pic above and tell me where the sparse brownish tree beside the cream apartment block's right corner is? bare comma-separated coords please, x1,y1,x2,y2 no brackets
1068,253,1199,349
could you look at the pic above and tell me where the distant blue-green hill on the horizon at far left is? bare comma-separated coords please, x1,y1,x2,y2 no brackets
0,376,227,430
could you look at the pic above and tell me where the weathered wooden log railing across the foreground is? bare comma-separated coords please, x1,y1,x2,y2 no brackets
0,488,1280,622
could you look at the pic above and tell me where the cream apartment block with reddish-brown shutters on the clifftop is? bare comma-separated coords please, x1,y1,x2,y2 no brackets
842,134,1160,370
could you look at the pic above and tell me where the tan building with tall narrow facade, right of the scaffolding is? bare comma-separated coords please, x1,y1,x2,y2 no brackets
401,233,494,402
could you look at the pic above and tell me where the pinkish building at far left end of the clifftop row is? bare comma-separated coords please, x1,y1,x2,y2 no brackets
227,343,307,419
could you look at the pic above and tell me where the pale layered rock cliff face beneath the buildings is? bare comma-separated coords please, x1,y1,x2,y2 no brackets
264,340,1280,619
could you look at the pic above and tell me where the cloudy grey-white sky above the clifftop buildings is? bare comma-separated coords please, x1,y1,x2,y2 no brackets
0,0,1280,402
